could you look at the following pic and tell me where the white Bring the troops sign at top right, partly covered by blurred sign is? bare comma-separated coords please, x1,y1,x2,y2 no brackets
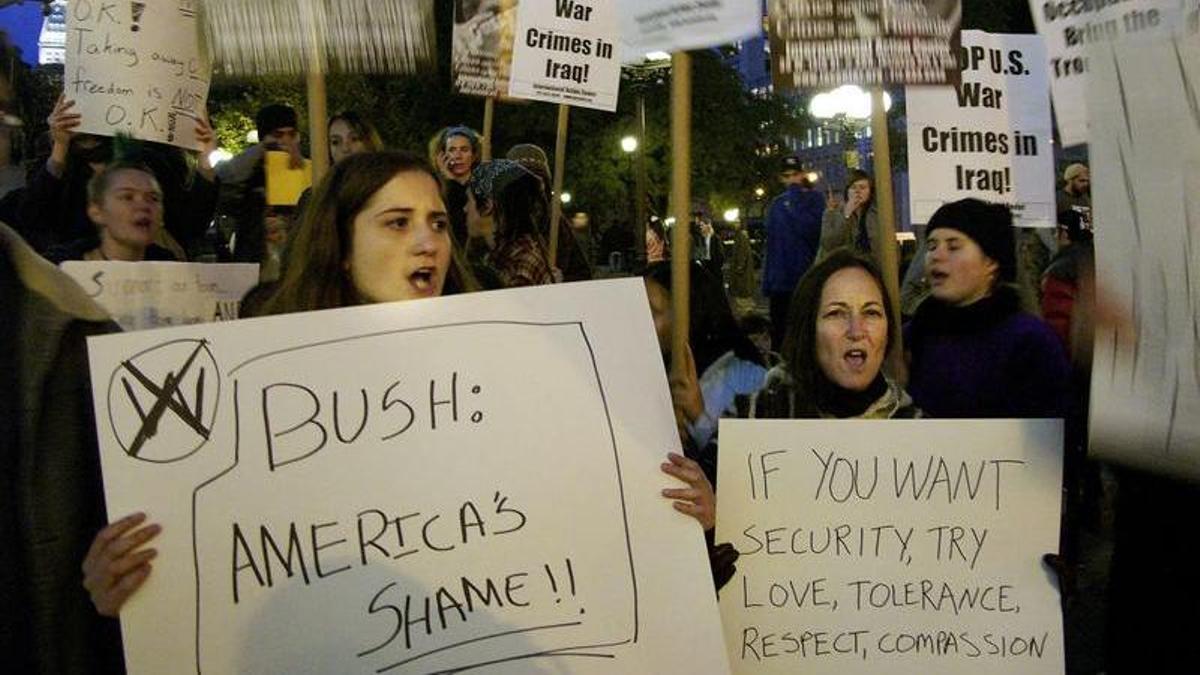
1030,0,1195,147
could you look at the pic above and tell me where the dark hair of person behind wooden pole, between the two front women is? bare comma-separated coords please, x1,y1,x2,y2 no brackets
643,261,766,376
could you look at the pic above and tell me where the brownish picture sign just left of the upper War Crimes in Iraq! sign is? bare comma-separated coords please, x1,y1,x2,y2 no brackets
450,0,518,96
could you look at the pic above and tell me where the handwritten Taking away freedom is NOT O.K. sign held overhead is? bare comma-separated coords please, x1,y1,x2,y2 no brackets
62,0,209,150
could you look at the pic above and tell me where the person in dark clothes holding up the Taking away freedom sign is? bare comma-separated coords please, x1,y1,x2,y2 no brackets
14,96,217,259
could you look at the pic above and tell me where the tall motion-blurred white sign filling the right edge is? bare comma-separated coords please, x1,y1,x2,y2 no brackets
1076,25,1200,479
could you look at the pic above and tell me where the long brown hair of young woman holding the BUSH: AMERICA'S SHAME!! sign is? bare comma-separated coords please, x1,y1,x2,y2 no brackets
262,151,475,315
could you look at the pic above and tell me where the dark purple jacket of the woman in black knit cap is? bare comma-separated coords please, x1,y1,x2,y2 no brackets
905,287,1070,418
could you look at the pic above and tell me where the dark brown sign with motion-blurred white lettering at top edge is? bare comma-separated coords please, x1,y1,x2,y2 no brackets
767,0,962,91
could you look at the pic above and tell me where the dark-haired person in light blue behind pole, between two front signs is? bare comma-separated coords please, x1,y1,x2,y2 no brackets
642,261,767,484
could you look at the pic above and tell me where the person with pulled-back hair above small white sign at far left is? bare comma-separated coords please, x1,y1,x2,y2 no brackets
46,162,175,264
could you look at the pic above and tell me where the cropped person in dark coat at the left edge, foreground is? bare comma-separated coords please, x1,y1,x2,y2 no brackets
0,223,125,675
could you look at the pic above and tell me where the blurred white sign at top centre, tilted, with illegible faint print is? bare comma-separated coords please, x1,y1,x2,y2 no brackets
614,0,762,62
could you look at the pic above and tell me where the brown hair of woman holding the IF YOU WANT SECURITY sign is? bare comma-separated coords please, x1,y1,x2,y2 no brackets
780,249,900,412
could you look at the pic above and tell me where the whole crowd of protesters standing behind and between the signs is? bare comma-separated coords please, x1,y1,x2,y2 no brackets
0,90,1190,673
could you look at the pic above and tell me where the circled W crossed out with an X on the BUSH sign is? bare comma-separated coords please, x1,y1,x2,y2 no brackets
108,340,220,462
